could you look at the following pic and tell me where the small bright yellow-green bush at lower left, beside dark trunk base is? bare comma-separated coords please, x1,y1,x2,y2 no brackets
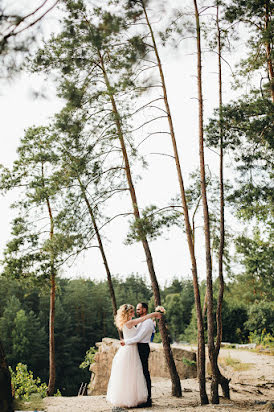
10,363,47,401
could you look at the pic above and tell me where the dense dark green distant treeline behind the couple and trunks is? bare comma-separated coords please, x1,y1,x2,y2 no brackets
0,275,274,396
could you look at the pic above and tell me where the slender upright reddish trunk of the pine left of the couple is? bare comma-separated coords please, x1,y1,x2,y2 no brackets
47,198,56,396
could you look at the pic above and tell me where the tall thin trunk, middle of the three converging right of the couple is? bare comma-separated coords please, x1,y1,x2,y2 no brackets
193,0,219,403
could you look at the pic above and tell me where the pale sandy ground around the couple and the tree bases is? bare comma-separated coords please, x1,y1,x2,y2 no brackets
45,348,274,412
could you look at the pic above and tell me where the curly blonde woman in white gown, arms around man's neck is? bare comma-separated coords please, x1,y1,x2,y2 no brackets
106,304,161,408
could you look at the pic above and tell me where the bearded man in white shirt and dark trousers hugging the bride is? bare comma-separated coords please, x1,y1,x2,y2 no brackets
121,302,157,408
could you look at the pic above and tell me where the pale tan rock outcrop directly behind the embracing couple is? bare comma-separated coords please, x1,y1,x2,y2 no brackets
88,338,197,395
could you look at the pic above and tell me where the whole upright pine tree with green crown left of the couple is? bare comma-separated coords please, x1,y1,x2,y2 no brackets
1,128,81,395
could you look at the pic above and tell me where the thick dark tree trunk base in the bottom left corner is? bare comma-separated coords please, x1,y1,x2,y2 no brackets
0,340,14,412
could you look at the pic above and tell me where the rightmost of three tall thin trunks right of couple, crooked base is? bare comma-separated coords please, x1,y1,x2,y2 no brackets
214,3,230,399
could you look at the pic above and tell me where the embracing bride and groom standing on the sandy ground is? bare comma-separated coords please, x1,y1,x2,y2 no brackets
107,303,162,408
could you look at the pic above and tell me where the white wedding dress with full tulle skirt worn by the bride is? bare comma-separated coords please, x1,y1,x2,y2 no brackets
106,325,147,408
